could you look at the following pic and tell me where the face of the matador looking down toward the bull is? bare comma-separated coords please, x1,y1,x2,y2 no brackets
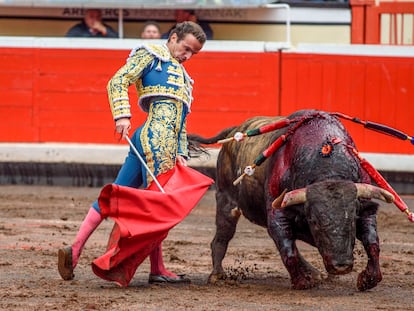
167,33,203,63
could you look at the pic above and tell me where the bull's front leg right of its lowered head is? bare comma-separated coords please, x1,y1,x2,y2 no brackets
357,210,382,291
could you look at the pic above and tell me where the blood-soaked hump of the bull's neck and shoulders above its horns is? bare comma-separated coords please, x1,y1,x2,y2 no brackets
268,111,370,197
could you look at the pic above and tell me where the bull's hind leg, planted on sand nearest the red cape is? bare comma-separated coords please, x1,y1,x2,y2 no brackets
208,190,241,284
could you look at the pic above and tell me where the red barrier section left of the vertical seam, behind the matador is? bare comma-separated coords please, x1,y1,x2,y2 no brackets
0,48,279,143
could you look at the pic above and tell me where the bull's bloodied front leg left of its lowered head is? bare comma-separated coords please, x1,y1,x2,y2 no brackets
268,211,321,289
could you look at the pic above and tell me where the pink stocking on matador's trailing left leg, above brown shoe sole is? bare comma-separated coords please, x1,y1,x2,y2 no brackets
72,207,102,268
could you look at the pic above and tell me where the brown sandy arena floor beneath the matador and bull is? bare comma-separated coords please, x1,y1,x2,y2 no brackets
0,186,414,311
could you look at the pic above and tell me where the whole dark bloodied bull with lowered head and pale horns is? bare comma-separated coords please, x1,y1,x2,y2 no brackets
189,110,393,291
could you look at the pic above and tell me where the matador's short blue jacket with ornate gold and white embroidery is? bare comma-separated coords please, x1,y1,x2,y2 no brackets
107,44,193,120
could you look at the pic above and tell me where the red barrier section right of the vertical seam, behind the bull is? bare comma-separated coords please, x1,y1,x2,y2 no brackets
281,53,414,154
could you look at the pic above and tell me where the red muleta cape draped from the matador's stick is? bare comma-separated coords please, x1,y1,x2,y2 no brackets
92,164,213,286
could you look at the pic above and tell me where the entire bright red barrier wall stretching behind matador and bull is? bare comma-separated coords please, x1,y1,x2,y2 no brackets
0,47,414,154
